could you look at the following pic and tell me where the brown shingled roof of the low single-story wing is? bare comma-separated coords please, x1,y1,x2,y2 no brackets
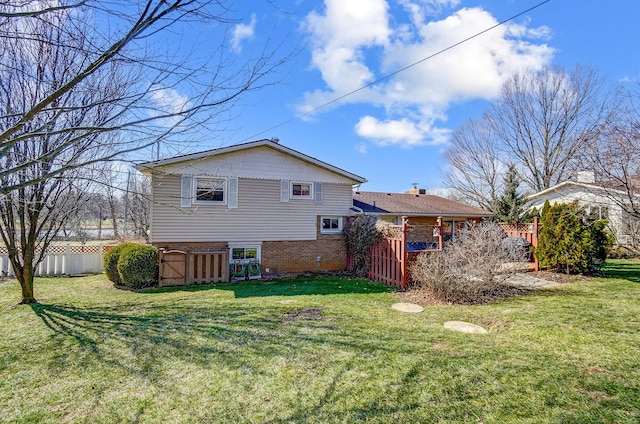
353,191,494,217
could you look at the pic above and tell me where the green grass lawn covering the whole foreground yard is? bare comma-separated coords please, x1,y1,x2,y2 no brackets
0,261,640,423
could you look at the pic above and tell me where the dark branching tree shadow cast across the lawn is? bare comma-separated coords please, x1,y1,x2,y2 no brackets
30,301,408,380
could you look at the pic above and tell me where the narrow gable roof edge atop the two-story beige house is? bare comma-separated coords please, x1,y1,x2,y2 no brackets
135,139,367,183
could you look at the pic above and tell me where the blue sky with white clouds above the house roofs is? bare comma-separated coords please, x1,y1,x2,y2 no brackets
158,0,640,192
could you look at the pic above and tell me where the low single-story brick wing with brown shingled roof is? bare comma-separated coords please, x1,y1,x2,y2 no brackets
353,188,493,248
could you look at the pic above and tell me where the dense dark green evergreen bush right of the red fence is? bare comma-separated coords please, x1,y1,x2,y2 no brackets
536,202,613,274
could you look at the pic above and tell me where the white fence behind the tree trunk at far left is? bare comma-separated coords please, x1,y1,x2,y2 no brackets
0,244,112,277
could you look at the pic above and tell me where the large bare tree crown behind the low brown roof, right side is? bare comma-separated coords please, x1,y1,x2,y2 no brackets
447,67,603,210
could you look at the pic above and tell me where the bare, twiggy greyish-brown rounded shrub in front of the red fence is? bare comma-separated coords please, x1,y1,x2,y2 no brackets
411,223,528,304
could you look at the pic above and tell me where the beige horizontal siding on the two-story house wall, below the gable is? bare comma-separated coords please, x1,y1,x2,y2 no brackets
151,175,352,243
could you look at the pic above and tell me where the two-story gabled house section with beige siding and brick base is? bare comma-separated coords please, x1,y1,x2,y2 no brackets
136,139,366,277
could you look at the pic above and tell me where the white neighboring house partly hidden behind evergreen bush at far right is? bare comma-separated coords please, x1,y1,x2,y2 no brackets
525,172,640,245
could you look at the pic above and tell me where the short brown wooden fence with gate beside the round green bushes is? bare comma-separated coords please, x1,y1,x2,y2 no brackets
158,250,229,287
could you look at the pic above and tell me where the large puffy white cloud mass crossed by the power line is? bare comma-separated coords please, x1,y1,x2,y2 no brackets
299,0,554,147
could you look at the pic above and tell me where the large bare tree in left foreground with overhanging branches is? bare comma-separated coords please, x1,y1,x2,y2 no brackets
0,0,283,303
